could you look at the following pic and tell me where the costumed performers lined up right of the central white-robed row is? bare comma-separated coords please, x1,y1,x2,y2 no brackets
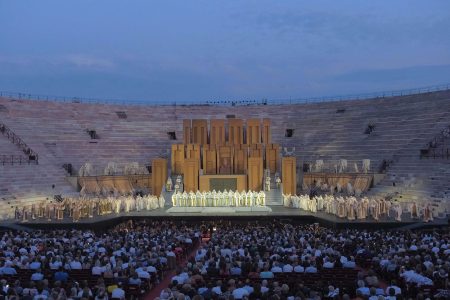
283,194,433,222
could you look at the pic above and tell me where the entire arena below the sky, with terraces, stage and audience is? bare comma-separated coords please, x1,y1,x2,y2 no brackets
0,89,450,299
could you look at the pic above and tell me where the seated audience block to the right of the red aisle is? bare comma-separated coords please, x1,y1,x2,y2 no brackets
159,222,450,300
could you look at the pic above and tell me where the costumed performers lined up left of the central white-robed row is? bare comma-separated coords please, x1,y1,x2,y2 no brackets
14,195,165,222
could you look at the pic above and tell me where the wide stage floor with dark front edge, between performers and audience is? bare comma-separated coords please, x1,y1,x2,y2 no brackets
0,206,449,229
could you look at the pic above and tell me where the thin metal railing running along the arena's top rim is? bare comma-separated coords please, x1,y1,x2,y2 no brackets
0,83,450,106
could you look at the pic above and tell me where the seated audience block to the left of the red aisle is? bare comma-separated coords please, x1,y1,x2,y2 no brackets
0,221,200,300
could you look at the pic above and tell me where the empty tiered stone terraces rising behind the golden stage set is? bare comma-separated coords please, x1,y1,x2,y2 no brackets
0,91,450,214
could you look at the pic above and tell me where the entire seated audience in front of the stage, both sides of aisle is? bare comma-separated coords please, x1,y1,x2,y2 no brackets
0,220,450,300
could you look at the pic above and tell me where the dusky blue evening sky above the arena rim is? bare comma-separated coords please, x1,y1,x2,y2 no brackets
0,0,450,101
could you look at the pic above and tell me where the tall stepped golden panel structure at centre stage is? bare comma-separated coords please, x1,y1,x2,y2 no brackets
171,119,281,191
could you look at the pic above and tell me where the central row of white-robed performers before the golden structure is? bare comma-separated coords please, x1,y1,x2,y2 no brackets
172,190,266,207
